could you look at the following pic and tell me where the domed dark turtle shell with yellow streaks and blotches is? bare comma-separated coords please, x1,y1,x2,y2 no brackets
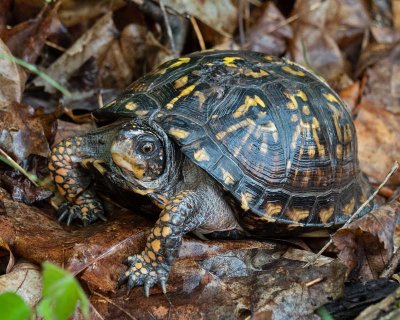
95,51,368,230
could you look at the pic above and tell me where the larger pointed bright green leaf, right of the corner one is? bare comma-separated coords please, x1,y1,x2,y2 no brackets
38,262,89,320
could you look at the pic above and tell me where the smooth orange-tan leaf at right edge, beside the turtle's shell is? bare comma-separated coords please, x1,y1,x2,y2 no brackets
354,102,400,185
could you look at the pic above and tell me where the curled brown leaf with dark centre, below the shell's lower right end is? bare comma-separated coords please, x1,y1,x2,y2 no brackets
332,201,400,281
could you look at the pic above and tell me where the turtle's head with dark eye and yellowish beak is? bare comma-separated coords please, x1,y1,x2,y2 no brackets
111,121,166,182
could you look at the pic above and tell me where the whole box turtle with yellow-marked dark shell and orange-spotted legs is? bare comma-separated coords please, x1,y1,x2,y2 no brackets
49,51,373,296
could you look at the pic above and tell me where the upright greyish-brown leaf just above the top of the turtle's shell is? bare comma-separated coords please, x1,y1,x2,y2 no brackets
246,2,293,55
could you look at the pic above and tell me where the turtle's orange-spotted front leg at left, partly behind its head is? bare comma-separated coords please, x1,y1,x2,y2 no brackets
49,137,105,225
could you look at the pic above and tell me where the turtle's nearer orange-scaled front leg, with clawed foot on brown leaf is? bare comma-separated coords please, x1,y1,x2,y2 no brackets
118,191,200,297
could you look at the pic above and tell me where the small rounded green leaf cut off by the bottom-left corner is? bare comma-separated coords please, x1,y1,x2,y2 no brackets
0,292,32,320
